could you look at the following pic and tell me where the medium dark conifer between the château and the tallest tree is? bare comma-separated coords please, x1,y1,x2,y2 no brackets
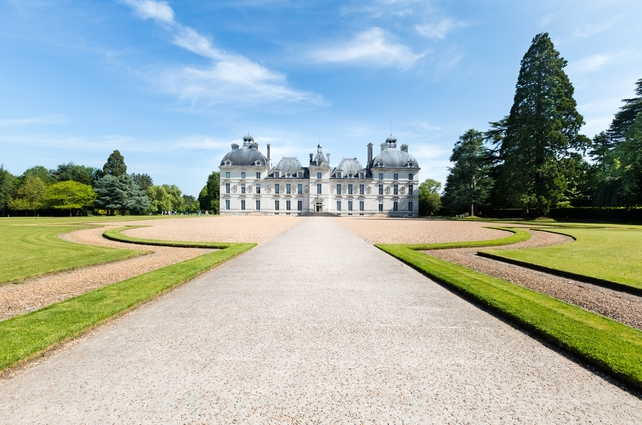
444,129,493,216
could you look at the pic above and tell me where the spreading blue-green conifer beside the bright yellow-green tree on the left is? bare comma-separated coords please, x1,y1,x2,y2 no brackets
94,174,150,215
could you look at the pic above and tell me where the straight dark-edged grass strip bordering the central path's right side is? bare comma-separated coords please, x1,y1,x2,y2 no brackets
375,244,642,390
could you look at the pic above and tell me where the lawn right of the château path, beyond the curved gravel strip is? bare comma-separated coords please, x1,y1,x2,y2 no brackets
485,227,642,290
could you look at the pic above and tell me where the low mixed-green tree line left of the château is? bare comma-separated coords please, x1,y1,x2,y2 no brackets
0,150,219,216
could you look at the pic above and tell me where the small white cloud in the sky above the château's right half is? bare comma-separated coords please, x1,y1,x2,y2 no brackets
310,27,427,68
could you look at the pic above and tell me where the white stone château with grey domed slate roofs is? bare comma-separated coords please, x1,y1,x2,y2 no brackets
219,135,420,217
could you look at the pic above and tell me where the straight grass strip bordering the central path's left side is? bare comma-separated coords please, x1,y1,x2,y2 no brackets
0,243,256,374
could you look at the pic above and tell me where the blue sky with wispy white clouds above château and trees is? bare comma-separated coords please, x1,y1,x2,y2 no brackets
0,0,642,195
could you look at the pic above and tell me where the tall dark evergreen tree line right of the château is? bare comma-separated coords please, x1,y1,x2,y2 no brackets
419,33,642,217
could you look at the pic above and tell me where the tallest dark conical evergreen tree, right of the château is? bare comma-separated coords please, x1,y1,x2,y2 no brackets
499,33,587,216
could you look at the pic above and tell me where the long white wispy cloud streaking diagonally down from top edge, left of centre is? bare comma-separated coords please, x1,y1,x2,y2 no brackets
125,0,326,106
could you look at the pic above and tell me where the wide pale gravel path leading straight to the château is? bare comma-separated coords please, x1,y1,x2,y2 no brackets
0,218,642,424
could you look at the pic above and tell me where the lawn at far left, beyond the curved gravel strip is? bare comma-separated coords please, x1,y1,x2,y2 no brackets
0,219,146,283
